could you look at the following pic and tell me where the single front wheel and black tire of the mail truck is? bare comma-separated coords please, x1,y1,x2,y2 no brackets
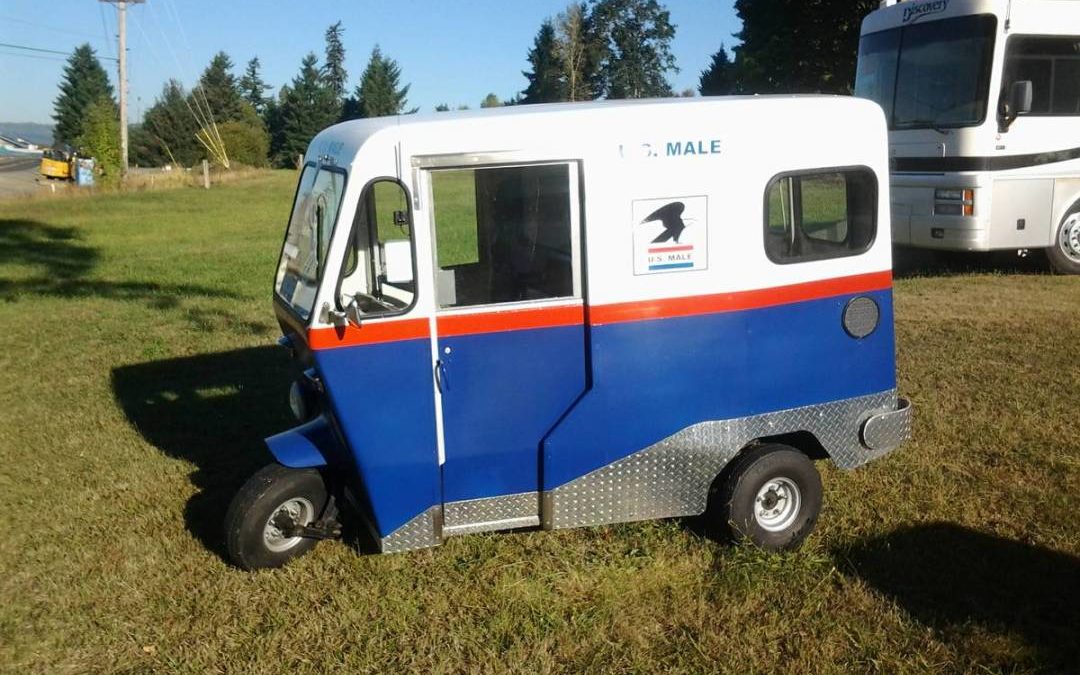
225,463,329,569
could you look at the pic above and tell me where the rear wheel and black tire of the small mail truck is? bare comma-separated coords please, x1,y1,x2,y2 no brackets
716,444,822,551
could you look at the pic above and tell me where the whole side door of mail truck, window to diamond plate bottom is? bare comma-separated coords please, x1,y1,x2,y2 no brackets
428,163,585,527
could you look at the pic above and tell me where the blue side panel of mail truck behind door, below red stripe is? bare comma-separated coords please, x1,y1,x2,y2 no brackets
542,291,896,490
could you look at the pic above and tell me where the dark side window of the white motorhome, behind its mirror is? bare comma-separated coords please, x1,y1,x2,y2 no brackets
1002,36,1080,116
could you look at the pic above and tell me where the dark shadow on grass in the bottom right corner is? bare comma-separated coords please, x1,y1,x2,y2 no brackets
834,523,1080,672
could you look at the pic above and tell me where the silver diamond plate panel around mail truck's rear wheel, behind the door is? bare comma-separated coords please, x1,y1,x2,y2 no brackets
543,390,909,529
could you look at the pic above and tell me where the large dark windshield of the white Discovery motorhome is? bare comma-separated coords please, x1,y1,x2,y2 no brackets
855,14,997,129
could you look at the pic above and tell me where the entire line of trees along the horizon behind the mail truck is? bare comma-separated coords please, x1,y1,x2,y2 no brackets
54,0,877,176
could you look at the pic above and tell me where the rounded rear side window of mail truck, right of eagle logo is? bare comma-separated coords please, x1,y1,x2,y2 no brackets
765,168,877,264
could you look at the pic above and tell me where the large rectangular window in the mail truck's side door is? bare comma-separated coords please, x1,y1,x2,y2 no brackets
431,164,573,308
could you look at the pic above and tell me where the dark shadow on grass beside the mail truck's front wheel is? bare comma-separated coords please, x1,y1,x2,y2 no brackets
112,346,308,557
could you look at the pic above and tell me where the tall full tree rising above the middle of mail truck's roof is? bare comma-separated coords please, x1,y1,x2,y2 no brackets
591,0,678,98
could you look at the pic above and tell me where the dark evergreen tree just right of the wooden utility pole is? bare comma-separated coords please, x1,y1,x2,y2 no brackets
140,80,204,166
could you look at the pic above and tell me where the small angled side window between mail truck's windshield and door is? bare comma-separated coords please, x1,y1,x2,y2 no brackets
338,179,416,314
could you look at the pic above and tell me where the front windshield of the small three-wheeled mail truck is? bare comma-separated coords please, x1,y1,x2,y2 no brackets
274,164,346,321
